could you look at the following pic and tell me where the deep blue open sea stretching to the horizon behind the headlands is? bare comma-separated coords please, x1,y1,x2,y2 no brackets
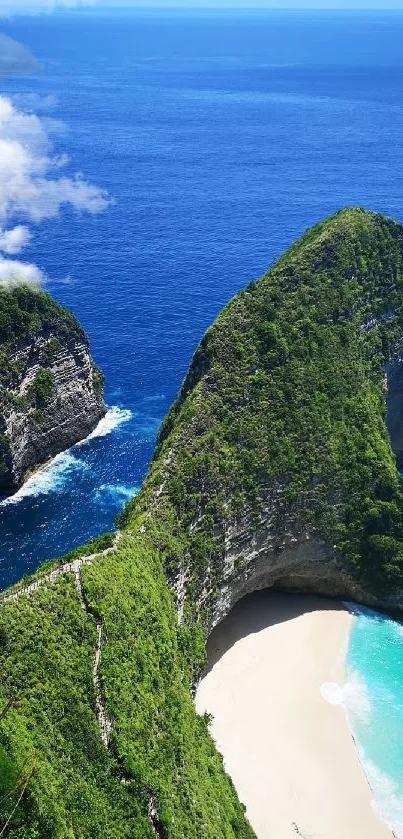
0,12,403,586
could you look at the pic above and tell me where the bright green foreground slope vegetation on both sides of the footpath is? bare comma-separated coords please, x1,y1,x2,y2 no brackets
0,536,253,839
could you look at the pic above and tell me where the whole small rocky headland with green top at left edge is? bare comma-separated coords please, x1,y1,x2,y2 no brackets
0,286,105,493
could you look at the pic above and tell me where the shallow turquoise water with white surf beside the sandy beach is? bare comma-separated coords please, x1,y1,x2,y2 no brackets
344,604,403,839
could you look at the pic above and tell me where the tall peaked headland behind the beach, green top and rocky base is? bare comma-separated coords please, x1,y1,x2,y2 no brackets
128,209,403,631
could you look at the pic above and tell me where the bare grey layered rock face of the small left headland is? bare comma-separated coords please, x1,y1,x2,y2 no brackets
0,295,105,492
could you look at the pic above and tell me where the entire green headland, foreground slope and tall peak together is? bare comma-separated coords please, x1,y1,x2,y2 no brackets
0,209,403,839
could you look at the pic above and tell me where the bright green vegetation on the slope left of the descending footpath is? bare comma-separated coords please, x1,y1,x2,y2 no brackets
0,575,152,839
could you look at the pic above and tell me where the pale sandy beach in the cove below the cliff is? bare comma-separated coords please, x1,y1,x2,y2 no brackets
196,591,392,839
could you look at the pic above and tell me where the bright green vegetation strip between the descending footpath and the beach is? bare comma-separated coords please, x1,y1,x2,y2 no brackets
83,535,253,839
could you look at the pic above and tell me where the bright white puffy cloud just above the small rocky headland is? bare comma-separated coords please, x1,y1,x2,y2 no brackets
0,95,110,284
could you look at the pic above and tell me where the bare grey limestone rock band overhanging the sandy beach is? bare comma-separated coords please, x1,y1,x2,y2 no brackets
171,480,403,635
